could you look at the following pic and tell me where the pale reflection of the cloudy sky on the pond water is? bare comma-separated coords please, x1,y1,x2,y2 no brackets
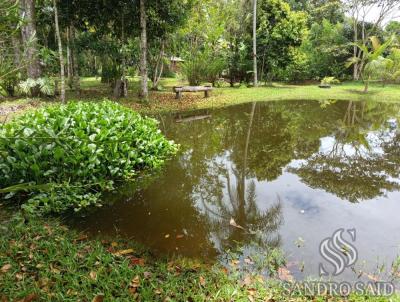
195,121,400,278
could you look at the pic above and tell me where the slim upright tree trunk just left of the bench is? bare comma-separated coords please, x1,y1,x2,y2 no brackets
139,0,149,99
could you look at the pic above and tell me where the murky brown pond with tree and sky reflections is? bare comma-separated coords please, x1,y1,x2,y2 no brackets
74,101,400,278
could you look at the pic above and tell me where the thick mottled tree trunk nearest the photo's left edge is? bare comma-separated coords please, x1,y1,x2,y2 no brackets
20,0,41,96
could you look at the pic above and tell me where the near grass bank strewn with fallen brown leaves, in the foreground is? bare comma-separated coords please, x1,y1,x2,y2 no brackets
0,213,397,302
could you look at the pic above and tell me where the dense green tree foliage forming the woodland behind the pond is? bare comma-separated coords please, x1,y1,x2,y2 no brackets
0,0,400,97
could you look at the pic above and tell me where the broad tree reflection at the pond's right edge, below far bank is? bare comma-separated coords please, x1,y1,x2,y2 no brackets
289,102,400,202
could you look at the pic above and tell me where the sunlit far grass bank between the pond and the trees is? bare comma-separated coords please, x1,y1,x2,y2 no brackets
0,77,400,118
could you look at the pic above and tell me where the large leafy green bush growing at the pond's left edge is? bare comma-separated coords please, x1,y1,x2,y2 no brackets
0,101,177,213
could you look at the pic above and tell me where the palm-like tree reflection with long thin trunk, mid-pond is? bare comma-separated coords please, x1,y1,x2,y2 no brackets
195,103,283,251
